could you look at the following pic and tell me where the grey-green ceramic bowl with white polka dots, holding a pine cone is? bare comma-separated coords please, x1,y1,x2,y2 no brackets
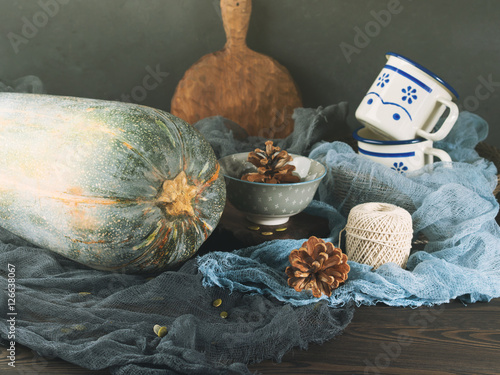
219,152,326,225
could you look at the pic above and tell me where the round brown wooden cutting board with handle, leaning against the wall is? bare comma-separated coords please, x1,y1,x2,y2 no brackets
171,0,302,138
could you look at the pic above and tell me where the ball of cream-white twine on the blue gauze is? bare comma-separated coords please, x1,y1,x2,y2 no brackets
345,202,413,269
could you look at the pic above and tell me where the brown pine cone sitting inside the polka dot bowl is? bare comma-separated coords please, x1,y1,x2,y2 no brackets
241,141,300,184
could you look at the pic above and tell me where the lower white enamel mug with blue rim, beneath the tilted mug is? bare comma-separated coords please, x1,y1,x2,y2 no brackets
353,128,451,173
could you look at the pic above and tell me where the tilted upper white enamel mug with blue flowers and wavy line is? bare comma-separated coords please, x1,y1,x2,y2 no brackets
355,52,458,141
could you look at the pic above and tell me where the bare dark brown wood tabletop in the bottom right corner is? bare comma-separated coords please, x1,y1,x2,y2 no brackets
250,299,500,375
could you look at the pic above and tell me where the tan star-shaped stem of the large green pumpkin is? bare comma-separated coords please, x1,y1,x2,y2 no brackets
156,171,198,216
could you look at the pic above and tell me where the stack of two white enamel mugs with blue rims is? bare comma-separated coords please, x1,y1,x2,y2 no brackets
353,52,458,173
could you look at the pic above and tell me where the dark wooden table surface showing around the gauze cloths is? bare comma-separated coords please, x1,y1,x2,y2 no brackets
0,204,500,375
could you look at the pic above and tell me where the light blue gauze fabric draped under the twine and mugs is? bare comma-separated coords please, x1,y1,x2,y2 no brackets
198,112,500,307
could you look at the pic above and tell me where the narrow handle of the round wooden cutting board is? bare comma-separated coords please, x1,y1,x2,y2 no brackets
220,0,252,50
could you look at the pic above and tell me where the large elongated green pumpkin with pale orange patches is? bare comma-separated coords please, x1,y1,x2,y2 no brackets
0,93,225,273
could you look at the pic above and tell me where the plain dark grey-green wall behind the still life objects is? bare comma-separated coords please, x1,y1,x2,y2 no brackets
0,0,500,147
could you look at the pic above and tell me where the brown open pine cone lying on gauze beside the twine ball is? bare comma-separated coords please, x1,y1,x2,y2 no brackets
285,236,350,298
